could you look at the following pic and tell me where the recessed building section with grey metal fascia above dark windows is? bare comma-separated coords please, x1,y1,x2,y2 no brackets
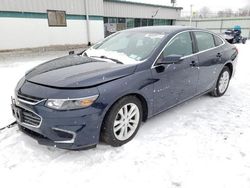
103,0,182,36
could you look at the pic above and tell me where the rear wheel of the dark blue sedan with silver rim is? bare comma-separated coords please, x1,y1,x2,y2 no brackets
210,66,231,97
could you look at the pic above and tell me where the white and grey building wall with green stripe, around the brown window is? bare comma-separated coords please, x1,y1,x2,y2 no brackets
0,0,104,50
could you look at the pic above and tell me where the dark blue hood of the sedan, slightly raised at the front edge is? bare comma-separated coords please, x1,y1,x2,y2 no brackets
25,55,136,88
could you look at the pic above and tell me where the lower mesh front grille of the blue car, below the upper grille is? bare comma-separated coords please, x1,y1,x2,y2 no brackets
21,109,41,127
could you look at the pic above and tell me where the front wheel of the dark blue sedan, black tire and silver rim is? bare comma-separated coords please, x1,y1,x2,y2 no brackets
101,96,142,147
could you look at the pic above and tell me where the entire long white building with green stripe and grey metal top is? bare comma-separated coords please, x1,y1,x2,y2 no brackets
0,0,182,51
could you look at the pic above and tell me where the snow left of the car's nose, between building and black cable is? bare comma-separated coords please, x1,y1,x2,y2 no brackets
0,52,67,128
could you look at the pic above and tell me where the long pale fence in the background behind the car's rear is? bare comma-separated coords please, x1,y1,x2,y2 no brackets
175,17,250,38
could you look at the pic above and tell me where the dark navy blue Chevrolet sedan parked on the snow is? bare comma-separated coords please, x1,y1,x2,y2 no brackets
12,26,238,149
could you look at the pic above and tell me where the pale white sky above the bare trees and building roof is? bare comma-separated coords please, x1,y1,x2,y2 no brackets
131,0,250,12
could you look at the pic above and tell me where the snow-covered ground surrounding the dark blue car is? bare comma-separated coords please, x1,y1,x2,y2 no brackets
0,42,250,188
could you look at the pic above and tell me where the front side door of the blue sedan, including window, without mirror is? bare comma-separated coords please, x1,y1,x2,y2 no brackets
152,32,199,113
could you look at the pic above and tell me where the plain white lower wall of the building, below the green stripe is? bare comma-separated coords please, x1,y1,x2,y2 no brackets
0,18,104,50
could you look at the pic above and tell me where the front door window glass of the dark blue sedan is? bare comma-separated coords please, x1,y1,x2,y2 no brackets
163,32,193,57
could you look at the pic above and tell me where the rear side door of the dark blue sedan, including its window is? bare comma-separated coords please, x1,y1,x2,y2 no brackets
193,31,223,93
